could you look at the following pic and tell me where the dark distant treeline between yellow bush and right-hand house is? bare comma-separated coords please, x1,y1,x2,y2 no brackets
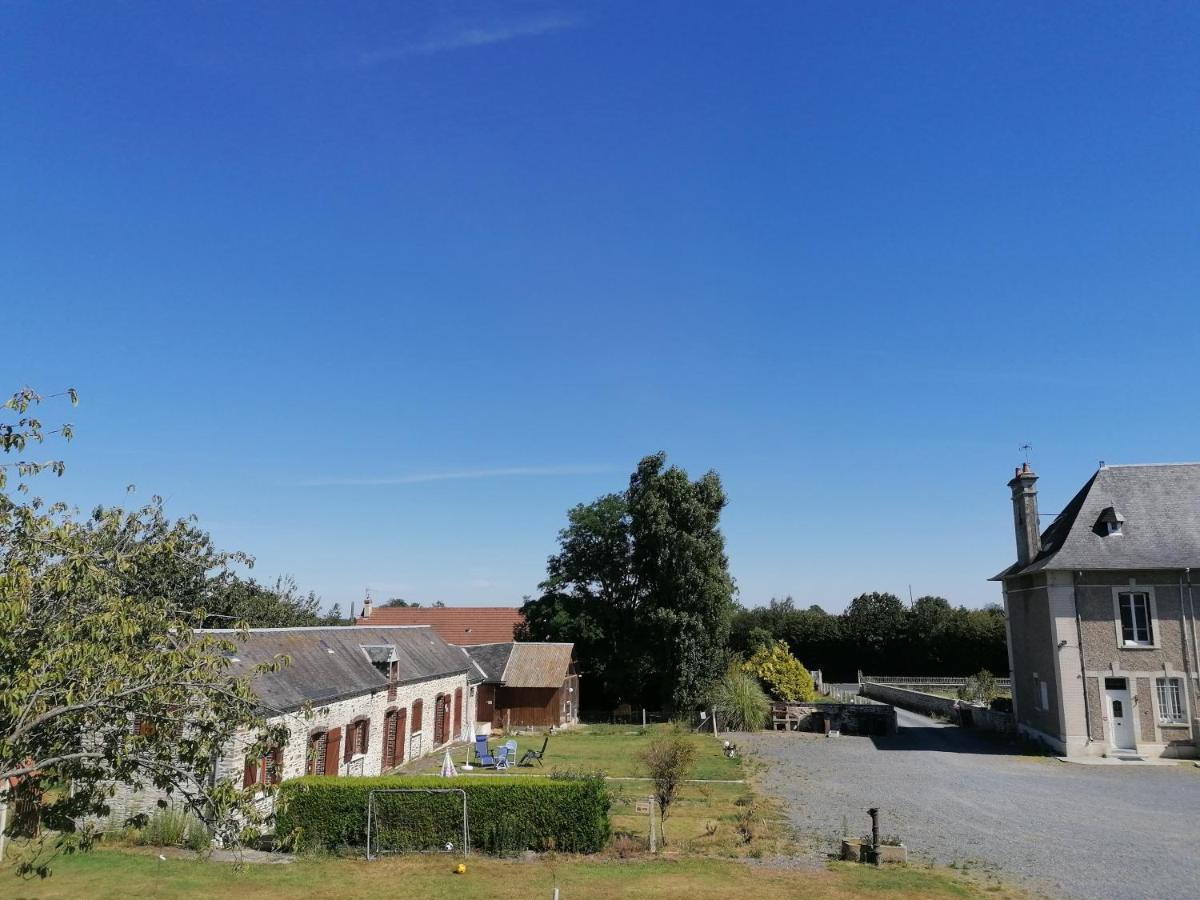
730,593,1008,682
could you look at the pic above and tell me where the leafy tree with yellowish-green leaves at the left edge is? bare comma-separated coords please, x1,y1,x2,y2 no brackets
0,394,282,874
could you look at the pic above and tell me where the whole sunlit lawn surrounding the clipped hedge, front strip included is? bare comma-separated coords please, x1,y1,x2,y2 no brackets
0,725,1022,900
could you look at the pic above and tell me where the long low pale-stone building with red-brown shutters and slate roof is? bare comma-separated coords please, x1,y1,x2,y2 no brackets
109,626,482,822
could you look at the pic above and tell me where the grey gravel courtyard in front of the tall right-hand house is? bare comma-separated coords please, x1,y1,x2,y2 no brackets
738,710,1200,900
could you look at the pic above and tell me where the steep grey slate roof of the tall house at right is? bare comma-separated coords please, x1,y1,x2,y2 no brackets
996,463,1200,580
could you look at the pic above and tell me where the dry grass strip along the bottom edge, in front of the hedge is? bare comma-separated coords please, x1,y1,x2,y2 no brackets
0,850,1019,900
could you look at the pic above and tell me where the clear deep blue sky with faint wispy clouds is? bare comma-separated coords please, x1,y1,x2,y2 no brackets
0,0,1200,610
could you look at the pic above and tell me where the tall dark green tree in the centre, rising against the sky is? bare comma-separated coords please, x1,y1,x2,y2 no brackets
518,454,734,710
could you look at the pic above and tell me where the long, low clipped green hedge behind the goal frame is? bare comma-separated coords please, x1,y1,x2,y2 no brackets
275,775,611,853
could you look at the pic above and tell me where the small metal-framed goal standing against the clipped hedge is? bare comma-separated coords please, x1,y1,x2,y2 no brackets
367,787,470,859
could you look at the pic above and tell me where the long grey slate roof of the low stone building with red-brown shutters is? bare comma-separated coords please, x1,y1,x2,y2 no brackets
203,625,473,710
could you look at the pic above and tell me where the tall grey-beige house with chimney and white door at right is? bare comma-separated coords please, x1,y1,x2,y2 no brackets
994,463,1200,757
